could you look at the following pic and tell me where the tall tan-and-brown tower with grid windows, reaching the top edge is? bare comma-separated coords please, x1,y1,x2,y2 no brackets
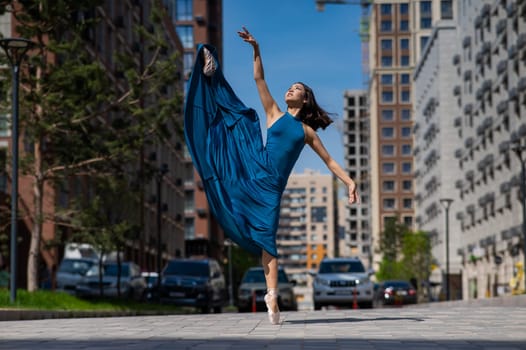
369,0,453,269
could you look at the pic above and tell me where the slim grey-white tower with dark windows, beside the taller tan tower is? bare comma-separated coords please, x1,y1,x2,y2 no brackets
338,90,372,267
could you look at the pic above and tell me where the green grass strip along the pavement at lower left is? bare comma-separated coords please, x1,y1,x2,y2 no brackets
0,289,188,313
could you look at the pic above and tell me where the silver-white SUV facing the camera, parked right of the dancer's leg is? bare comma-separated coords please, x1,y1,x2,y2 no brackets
312,258,374,310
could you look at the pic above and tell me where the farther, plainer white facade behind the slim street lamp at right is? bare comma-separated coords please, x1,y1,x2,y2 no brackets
413,20,462,299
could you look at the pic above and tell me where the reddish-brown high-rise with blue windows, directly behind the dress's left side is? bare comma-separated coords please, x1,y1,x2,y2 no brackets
163,0,223,260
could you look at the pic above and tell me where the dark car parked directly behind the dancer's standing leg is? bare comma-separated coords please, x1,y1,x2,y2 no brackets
237,267,298,312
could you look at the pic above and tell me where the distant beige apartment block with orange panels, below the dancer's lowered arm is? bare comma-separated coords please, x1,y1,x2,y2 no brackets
276,170,337,284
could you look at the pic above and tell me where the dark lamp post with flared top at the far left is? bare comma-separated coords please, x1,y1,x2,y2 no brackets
0,38,33,303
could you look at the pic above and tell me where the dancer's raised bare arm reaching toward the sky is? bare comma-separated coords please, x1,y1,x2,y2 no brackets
237,27,282,126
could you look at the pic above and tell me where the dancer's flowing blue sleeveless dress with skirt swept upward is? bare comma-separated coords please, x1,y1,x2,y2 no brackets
184,45,305,256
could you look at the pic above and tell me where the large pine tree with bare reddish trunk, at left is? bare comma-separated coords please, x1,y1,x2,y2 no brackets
0,0,182,291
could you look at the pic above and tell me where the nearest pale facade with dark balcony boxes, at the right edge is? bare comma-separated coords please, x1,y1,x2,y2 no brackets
448,0,526,299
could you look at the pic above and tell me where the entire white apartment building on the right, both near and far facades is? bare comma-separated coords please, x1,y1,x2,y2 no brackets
414,0,526,299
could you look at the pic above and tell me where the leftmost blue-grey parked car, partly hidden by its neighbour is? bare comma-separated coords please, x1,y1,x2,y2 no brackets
57,258,98,294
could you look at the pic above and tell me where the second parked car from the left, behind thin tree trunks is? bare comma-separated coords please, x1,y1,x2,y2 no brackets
76,262,146,300
